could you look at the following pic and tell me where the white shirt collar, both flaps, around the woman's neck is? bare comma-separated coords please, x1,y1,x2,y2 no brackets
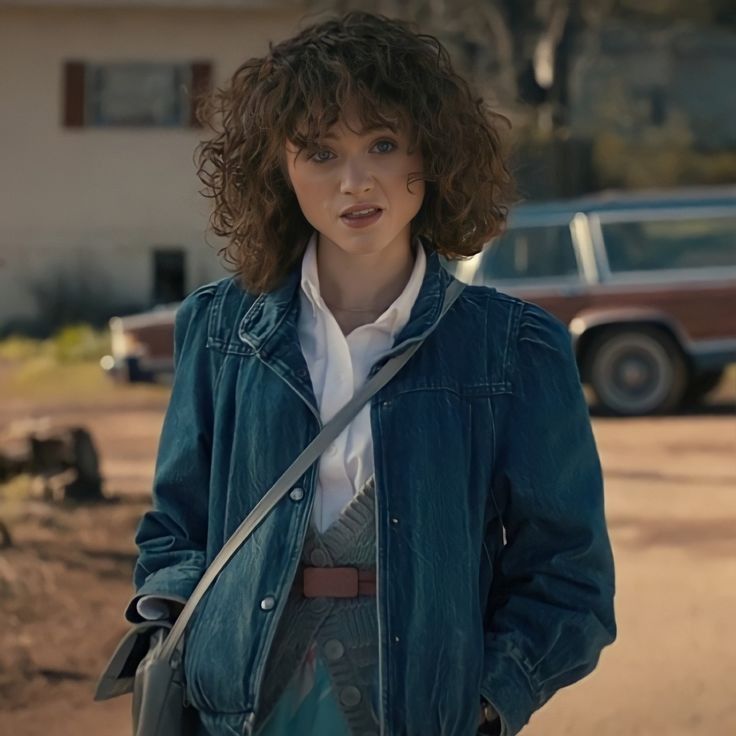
301,230,427,335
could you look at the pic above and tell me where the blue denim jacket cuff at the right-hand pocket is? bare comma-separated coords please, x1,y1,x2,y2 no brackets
480,653,539,736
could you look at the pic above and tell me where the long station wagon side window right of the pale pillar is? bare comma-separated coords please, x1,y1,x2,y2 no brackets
602,217,736,273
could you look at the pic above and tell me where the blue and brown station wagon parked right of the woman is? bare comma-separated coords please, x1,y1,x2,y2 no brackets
449,187,736,415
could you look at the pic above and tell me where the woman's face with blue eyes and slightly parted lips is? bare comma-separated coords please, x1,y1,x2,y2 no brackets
286,103,425,255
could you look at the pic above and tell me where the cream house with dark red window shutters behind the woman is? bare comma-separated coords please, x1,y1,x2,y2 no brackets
0,0,305,335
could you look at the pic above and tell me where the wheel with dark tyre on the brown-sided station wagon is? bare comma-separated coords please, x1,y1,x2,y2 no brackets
586,327,687,416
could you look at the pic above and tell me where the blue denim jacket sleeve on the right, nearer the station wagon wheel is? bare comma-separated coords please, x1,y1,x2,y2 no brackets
481,303,616,736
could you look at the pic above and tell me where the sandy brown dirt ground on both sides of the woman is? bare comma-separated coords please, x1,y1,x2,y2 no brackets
0,374,736,736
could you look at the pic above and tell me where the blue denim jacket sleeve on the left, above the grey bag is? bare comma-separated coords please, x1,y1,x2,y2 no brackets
125,285,217,622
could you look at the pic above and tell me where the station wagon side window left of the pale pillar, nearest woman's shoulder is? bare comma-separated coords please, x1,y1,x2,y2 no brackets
483,225,578,281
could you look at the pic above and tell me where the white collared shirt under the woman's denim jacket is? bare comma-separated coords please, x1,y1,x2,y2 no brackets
298,231,427,531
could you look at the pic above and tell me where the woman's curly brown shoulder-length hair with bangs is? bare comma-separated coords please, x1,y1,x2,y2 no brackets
195,11,514,292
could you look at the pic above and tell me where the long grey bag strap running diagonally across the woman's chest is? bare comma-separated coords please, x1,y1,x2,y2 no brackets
160,280,465,660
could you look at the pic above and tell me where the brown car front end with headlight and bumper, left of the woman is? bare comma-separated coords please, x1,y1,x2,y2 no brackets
100,303,179,383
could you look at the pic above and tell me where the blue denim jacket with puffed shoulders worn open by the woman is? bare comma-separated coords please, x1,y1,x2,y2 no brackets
127,247,616,736
